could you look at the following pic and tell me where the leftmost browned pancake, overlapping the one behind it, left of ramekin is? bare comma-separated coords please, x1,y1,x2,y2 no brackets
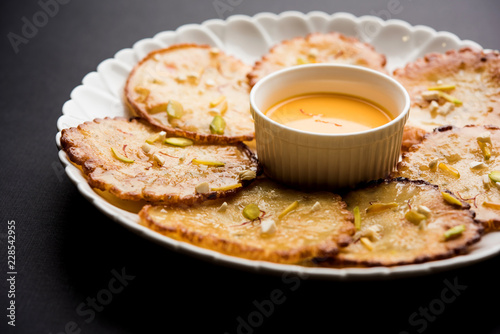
61,118,260,204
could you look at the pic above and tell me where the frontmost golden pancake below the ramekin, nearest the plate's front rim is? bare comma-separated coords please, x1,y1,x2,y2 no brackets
139,179,354,263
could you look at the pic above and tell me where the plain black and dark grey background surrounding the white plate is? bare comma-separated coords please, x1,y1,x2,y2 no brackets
0,0,500,334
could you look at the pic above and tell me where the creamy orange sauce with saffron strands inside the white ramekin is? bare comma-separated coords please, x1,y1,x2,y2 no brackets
266,93,392,133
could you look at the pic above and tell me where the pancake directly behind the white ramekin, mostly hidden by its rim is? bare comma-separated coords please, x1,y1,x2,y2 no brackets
248,32,386,86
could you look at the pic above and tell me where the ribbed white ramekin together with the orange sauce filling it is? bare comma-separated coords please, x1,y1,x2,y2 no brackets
250,64,410,189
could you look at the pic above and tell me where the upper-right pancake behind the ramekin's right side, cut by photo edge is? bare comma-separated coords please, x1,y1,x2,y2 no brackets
394,48,500,148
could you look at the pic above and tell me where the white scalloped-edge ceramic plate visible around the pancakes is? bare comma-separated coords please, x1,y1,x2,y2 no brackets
56,12,500,279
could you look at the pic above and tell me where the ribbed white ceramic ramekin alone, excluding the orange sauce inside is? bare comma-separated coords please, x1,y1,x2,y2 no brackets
250,64,410,189
